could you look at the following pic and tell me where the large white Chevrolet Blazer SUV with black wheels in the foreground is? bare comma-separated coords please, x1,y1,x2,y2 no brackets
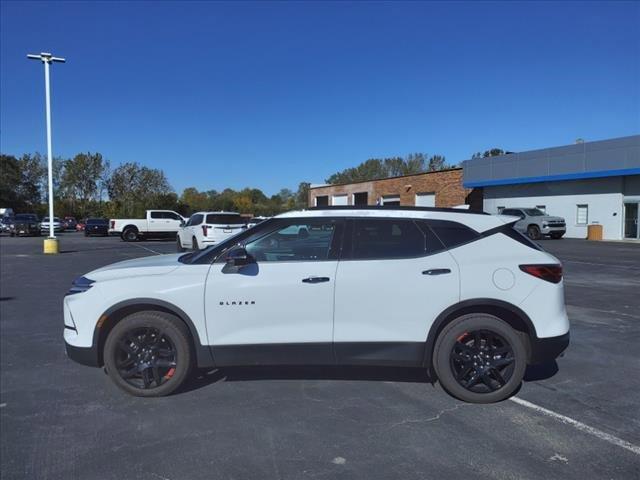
64,207,569,403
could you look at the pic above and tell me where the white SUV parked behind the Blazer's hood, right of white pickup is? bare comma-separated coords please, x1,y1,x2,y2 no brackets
177,212,247,252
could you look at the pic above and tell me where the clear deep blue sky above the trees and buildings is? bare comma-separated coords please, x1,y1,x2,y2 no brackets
0,1,640,194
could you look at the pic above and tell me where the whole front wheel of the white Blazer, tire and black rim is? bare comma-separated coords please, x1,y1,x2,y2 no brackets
104,311,194,397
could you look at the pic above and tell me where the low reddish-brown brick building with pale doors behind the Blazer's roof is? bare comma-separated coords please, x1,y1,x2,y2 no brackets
309,168,482,210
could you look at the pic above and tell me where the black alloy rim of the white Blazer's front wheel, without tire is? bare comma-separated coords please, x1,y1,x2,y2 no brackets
115,327,177,389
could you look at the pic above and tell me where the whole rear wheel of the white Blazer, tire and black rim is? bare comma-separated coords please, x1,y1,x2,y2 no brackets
433,313,527,403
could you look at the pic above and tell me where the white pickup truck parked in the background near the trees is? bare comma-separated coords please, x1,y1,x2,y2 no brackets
109,210,185,242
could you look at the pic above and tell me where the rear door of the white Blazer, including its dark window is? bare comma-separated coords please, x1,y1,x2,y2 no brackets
334,218,460,366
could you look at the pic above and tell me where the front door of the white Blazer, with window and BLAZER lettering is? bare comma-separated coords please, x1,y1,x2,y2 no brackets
205,218,342,365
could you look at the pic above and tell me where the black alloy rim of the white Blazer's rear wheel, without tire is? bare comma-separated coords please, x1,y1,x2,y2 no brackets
450,330,515,393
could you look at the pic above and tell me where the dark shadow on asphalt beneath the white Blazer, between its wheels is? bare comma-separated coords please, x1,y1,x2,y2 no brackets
180,366,433,393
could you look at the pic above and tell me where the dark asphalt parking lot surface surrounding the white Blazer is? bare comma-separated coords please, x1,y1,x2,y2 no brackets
0,233,640,480
